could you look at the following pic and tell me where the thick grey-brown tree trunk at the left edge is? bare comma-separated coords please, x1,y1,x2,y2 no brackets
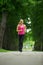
0,12,7,48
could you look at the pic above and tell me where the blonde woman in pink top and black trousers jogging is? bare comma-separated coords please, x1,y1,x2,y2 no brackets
17,19,26,52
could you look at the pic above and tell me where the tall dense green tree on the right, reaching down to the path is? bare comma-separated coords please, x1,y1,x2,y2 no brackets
31,0,43,51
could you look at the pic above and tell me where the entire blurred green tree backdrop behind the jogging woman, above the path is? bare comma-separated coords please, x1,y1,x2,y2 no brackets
0,0,43,51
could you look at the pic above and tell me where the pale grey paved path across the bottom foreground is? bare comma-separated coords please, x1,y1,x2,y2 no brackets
0,51,43,65
